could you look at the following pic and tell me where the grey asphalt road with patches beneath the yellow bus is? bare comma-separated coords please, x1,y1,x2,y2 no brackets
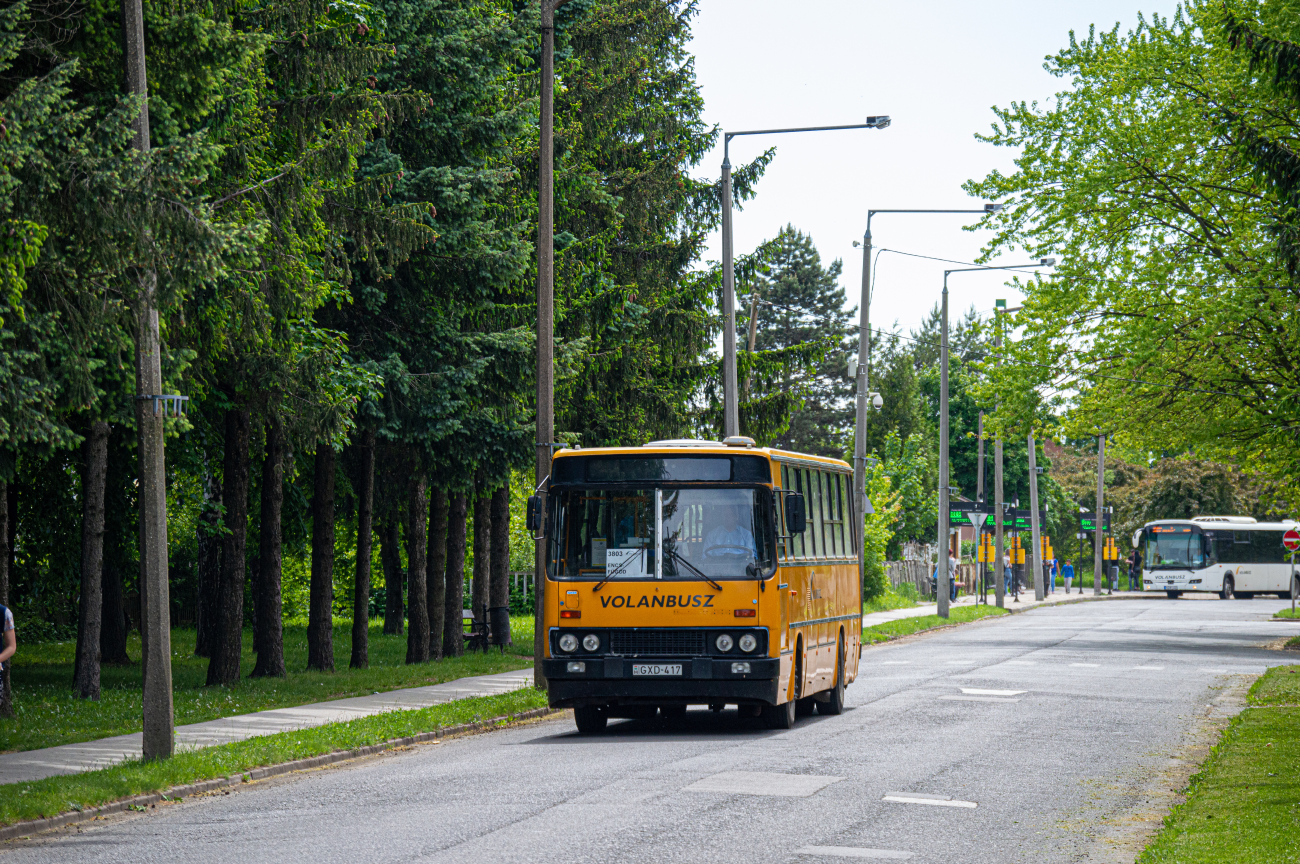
12,599,1300,864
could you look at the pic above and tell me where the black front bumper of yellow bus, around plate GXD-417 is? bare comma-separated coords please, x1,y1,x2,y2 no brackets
542,657,781,708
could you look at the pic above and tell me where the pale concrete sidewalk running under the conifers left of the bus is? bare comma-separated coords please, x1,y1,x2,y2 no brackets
0,669,533,783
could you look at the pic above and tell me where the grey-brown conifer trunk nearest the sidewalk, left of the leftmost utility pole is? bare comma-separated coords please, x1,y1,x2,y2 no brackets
73,421,108,702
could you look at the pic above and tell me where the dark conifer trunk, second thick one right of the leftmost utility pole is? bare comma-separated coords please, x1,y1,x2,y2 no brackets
252,412,285,678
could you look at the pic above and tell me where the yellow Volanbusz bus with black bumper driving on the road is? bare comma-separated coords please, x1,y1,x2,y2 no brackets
530,437,862,734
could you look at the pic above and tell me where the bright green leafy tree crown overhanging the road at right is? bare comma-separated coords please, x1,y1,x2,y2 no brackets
966,0,1300,502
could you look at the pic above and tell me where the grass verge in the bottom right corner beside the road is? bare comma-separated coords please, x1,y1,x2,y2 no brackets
1138,667,1300,864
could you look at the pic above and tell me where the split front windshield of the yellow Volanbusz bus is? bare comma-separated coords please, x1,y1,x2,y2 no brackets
547,487,775,579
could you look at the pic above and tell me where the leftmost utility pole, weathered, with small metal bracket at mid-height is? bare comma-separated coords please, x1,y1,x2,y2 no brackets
124,0,176,759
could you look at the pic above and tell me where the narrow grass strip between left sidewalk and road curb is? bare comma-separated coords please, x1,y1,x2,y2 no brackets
0,687,546,825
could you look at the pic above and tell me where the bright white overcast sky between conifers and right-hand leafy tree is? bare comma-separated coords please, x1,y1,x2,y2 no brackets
690,0,1175,340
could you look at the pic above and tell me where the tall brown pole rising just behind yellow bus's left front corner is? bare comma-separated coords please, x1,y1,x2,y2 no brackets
535,0,568,690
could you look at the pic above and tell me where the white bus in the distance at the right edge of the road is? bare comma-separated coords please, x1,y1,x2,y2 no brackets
1132,516,1300,600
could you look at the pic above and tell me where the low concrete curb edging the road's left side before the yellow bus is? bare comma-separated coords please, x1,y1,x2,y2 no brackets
0,708,560,842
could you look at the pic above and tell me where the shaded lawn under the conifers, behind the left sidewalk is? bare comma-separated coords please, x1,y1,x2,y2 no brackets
0,616,533,752
